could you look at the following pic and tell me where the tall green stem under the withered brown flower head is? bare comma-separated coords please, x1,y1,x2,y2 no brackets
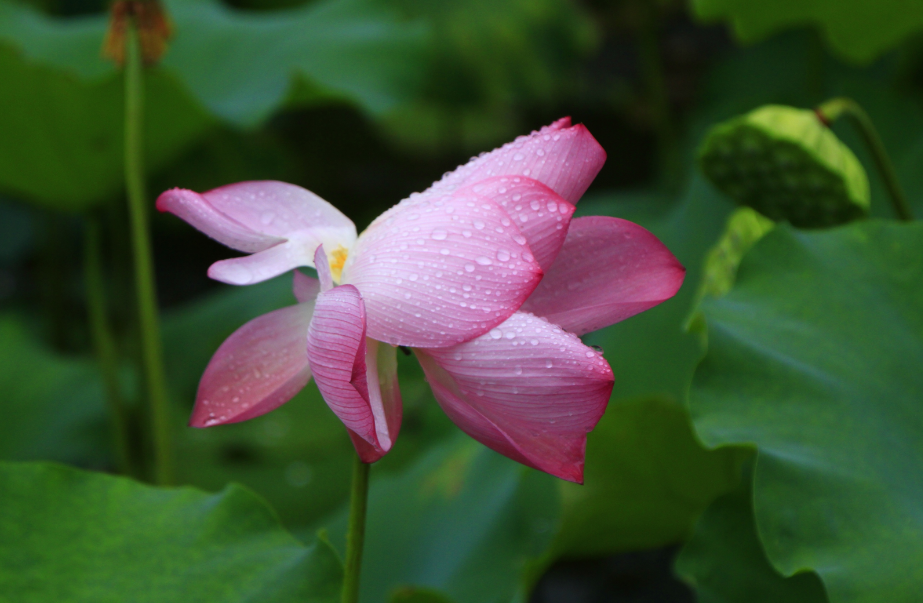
125,20,173,484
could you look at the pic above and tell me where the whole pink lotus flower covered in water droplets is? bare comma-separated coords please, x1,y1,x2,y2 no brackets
157,118,684,482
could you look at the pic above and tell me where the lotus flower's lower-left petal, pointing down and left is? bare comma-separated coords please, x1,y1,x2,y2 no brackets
189,303,314,427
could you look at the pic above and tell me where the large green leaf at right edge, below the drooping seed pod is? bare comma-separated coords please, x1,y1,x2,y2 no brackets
690,221,923,603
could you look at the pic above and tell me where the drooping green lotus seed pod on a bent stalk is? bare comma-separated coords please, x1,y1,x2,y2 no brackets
699,105,869,228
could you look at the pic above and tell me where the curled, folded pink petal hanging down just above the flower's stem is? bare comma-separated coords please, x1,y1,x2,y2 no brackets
308,285,400,463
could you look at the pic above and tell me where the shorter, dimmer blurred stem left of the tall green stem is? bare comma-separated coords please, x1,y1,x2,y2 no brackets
83,217,133,475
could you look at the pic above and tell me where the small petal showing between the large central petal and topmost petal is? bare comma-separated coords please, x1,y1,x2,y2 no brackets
458,176,576,270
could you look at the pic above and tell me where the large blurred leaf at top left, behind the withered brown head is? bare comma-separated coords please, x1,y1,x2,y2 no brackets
0,0,423,210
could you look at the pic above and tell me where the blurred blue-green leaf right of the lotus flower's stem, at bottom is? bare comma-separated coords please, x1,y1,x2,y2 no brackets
322,435,560,603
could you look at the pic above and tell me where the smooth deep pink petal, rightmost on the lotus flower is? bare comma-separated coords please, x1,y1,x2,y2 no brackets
522,216,686,335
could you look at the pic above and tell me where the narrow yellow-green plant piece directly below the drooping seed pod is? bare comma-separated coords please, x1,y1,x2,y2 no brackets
686,207,776,330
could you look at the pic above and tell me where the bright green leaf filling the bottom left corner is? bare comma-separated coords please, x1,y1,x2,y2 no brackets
0,463,343,603
